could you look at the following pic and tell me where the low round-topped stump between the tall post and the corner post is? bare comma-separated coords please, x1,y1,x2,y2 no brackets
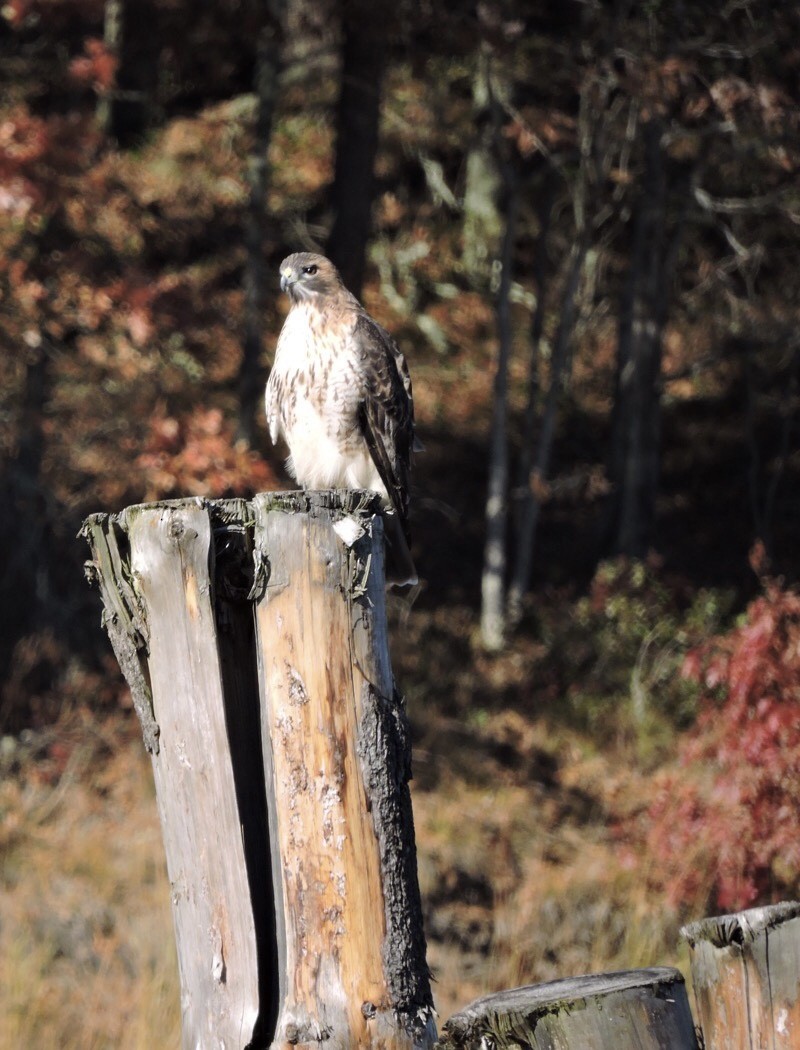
439,967,697,1050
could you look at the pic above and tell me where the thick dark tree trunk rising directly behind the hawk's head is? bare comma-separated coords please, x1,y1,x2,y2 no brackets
325,0,386,296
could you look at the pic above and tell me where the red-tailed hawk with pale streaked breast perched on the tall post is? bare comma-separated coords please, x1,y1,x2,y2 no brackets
267,252,417,585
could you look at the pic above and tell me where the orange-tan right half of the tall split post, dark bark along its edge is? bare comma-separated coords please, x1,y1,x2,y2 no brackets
254,494,435,1050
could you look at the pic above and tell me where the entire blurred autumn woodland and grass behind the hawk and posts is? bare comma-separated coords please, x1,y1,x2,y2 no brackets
0,0,800,1050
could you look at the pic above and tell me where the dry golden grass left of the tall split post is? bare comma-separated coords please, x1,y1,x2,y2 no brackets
0,722,180,1050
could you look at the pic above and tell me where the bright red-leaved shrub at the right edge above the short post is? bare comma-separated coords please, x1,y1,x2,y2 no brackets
647,558,800,909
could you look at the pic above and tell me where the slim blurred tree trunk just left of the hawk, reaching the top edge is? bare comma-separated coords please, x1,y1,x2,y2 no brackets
236,0,286,445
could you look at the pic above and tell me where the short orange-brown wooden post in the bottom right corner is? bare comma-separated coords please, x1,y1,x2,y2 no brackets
681,901,800,1050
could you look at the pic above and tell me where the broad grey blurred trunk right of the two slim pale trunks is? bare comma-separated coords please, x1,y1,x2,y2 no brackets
608,118,671,558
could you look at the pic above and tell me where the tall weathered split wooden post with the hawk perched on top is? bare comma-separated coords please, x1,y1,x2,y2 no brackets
83,492,436,1050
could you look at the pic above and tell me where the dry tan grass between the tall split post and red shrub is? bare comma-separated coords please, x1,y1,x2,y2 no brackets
407,719,689,1019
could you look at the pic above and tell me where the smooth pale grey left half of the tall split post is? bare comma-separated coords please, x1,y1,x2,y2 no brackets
125,503,259,1050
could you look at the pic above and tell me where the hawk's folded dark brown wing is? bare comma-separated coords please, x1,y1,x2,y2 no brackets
355,314,414,530
